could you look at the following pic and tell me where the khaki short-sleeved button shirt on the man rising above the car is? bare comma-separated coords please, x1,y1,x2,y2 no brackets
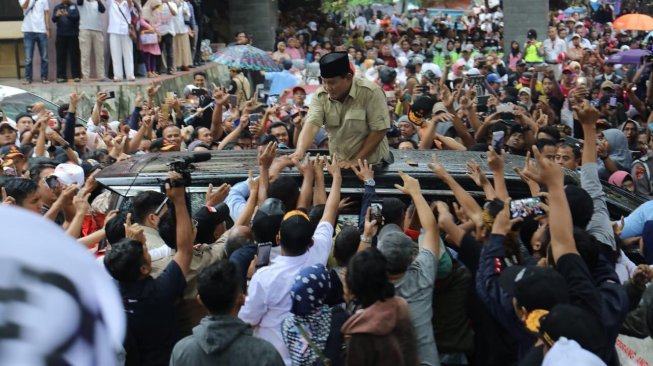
306,77,390,164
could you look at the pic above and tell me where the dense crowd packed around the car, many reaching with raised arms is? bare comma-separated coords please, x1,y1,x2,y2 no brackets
0,0,653,366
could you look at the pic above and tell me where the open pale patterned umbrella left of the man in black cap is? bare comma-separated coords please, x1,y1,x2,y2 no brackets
211,45,281,71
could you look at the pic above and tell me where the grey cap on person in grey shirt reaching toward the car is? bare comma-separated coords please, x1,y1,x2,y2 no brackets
377,224,417,274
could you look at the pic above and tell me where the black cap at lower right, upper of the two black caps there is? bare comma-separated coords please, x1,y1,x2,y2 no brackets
499,266,569,311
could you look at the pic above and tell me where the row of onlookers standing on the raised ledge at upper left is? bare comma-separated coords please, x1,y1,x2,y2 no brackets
18,0,209,84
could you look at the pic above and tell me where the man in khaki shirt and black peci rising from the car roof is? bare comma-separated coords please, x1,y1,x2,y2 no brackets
292,52,392,168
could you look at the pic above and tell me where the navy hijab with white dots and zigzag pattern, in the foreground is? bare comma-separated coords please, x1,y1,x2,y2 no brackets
281,264,331,366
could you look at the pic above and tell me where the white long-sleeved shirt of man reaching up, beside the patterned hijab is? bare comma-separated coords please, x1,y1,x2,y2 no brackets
238,221,333,366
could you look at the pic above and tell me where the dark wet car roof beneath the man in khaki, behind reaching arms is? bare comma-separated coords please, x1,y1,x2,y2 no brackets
96,150,646,219
